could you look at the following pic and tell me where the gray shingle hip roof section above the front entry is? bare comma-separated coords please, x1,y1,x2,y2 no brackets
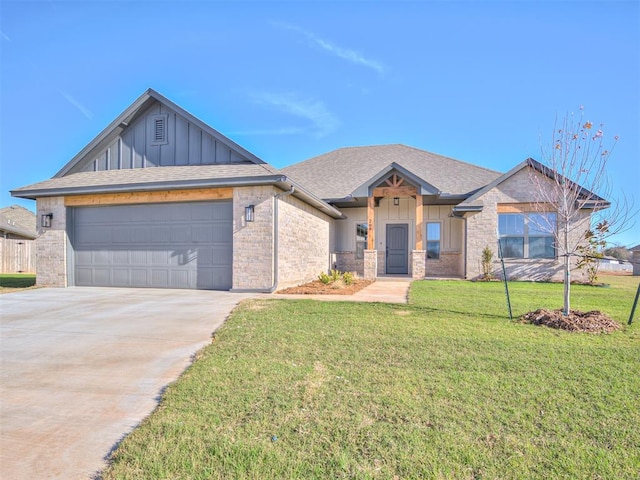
282,145,501,199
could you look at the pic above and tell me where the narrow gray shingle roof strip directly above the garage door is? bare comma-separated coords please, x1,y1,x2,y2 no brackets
11,164,282,198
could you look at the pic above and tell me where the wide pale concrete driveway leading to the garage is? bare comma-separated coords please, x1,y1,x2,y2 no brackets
0,287,255,480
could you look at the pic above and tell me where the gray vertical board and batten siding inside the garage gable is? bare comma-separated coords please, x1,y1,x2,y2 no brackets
83,103,249,171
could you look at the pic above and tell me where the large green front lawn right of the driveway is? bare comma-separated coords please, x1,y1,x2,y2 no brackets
104,277,640,479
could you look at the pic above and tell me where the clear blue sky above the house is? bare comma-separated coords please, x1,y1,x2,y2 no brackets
0,0,640,244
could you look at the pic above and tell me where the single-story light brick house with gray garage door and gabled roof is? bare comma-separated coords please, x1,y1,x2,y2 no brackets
12,90,604,291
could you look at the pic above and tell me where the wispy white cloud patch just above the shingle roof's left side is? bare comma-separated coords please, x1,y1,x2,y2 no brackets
254,93,340,138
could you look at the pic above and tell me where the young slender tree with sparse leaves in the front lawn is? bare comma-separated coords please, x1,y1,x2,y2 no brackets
530,107,633,315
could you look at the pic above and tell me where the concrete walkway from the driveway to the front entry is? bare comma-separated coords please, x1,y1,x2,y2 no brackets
272,277,413,303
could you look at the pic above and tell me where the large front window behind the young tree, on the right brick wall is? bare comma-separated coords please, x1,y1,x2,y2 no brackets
498,212,556,258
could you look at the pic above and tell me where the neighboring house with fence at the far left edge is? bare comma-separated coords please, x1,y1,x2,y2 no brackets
0,205,37,273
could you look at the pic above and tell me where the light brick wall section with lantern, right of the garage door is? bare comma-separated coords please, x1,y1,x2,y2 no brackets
233,186,279,289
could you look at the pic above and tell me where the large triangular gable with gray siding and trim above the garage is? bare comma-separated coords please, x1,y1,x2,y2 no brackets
55,89,264,177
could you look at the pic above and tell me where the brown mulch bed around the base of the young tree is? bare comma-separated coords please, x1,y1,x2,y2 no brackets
520,308,621,333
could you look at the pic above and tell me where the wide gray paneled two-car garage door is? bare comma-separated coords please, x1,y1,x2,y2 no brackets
71,201,233,290
